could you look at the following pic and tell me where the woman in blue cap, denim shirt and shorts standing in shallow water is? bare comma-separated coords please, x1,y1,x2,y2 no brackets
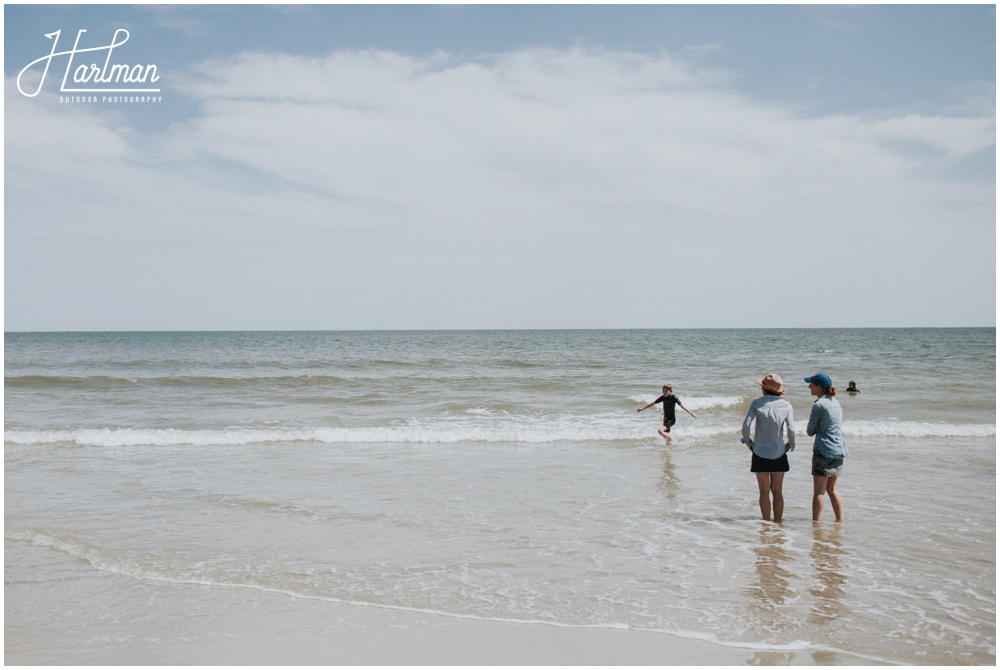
805,372,847,521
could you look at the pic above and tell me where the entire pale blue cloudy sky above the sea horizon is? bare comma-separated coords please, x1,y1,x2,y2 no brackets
4,4,996,332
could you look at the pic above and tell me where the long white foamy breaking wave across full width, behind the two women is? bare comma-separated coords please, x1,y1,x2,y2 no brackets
4,418,996,447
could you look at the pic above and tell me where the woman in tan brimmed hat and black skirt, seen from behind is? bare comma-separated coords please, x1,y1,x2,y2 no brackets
740,375,795,523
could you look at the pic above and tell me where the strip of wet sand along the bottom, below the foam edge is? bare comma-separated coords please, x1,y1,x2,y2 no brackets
5,572,852,665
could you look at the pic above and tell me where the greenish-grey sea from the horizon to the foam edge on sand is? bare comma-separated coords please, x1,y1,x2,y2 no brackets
4,328,996,664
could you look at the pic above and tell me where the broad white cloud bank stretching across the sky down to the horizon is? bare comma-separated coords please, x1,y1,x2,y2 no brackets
7,47,995,327
